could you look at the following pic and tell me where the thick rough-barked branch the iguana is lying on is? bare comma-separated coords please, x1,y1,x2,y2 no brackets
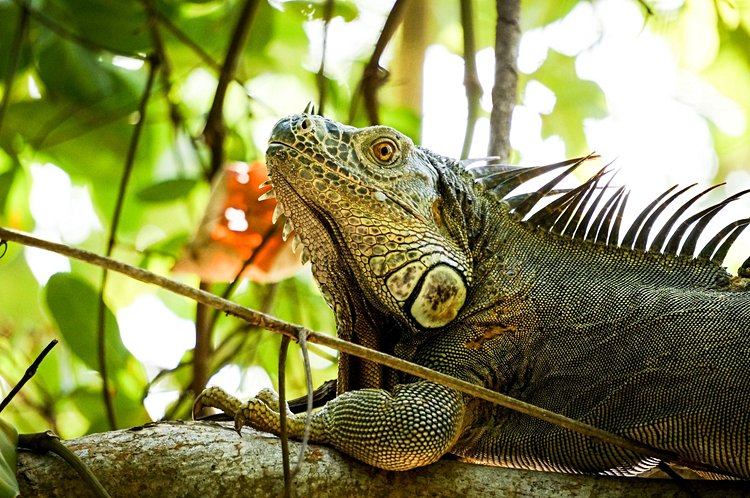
18,421,750,498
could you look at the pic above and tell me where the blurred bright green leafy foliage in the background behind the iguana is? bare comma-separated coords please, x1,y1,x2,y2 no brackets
0,0,750,444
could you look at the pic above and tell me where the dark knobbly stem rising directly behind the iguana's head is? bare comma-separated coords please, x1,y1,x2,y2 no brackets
349,0,407,125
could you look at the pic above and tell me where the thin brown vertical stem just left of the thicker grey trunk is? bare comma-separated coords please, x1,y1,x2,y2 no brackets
461,0,482,159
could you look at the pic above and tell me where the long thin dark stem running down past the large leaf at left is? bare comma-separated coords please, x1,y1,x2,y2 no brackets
96,53,159,429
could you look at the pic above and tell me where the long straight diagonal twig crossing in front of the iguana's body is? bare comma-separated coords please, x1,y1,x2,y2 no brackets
0,228,726,474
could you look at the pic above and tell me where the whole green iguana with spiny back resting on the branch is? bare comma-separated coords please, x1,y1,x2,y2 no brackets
196,113,750,478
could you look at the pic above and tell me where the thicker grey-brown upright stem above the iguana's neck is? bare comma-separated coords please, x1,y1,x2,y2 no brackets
487,0,521,161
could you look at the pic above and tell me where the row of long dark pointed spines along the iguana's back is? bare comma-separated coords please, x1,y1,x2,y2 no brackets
464,155,750,276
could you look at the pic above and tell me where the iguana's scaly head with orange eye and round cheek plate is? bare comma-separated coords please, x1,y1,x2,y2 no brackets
267,114,472,331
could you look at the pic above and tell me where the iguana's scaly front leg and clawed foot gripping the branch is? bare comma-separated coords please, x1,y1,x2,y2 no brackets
193,381,465,470
